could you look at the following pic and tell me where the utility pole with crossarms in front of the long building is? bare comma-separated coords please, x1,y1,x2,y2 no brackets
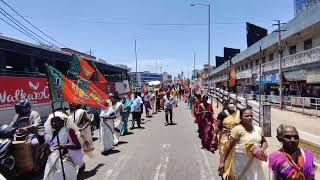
273,20,285,110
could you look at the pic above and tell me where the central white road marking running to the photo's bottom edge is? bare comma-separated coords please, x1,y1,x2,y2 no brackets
153,144,171,180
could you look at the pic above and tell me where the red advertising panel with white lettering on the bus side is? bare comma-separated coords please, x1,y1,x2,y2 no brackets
0,76,50,108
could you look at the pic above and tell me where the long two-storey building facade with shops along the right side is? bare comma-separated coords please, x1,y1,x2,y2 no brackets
210,4,320,97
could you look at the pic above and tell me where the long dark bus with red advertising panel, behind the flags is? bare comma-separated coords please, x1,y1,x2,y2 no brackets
0,35,130,124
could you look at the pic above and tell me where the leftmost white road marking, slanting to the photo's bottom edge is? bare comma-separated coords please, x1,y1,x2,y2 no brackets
104,152,130,180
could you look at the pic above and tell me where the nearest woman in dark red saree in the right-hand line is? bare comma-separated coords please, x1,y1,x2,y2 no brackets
198,95,218,152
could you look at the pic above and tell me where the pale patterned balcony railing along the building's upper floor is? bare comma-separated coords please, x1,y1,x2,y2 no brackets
252,47,320,74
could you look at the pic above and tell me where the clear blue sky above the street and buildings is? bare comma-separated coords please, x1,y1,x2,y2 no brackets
0,0,294,77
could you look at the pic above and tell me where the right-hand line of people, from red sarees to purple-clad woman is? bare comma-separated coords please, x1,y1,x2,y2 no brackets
186,86,315,180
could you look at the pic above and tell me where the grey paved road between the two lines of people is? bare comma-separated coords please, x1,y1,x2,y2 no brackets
83,102,219,180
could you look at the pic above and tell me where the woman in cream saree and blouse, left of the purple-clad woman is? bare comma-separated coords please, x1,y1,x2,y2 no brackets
219,108,268,180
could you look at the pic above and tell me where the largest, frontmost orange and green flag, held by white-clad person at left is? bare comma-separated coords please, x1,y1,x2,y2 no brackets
45,64,107,108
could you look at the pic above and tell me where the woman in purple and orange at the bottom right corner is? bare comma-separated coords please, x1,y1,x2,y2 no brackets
268,125,315,180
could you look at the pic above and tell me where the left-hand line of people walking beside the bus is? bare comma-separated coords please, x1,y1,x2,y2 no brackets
39,82,179,180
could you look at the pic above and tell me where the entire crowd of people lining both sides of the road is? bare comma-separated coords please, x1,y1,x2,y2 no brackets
8,82,315,180
